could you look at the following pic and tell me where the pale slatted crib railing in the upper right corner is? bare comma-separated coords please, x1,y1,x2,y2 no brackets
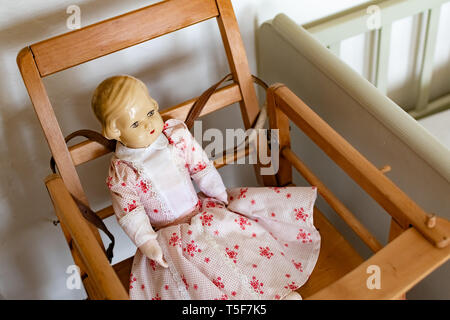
303,0,450,119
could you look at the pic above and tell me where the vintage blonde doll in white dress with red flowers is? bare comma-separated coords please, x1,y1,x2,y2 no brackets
92,76,320,300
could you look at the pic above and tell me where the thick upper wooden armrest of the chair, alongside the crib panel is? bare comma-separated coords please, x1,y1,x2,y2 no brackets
275,86,450,247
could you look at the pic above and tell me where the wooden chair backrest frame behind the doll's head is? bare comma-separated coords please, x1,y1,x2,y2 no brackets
17,0,259,204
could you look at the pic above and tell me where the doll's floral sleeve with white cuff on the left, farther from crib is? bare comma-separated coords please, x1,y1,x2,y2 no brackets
106,160,156,247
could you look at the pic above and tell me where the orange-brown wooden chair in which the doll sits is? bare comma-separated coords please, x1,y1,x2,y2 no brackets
17,0,450,299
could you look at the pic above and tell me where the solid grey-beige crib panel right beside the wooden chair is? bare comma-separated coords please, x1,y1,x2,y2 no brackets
258,11,450,299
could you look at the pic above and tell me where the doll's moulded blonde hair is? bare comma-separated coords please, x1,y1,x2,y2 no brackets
91,75,153,138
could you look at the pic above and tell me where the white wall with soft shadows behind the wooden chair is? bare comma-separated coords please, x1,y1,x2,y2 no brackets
0,0,444,299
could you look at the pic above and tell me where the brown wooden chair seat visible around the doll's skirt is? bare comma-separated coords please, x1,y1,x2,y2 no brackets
114,208,364,299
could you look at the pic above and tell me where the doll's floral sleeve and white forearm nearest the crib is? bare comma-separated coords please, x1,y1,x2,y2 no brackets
164,119,228,203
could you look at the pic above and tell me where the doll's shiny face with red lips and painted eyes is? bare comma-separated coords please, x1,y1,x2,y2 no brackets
113,93,164,148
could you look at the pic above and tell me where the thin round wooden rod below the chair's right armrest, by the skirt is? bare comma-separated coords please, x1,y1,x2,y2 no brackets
281,148,383,252
